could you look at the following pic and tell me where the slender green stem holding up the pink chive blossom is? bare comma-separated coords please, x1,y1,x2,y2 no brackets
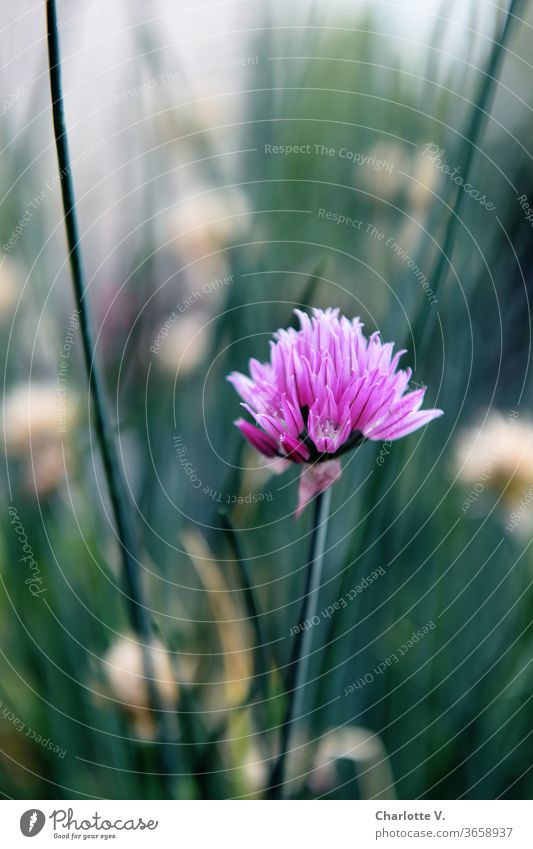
268,488,331,799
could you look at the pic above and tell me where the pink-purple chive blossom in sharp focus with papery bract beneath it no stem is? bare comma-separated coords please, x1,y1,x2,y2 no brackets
228,309,442,516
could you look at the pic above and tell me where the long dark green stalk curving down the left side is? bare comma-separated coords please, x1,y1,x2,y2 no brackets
46,0,174,790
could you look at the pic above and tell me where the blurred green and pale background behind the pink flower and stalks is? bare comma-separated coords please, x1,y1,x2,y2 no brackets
0,0,533,799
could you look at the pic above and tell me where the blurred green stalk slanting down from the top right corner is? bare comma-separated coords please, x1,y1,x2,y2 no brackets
413,0,524,351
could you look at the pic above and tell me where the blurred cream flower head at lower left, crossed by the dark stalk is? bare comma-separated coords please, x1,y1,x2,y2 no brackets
102,634,179,738
